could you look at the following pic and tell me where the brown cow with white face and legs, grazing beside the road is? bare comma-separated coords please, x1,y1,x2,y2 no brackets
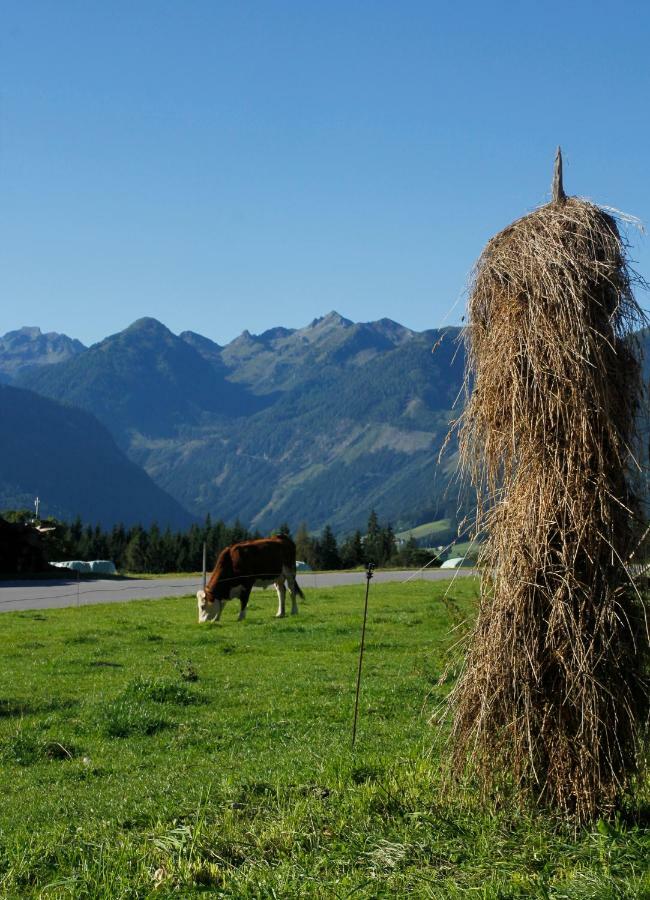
196,535,304,622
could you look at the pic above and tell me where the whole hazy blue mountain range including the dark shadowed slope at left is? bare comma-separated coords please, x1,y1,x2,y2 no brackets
6,312,650,537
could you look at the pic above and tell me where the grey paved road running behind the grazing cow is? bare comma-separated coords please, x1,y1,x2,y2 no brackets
0,569,476,612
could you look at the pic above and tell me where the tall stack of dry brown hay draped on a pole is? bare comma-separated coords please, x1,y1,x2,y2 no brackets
451,196,648,821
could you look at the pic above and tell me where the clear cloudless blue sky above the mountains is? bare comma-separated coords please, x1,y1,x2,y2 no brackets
0,0,650,343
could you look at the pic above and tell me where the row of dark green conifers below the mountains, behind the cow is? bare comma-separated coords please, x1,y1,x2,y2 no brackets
3,510,439,574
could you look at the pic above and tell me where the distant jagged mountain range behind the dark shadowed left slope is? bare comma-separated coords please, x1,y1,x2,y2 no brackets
0,312,463,533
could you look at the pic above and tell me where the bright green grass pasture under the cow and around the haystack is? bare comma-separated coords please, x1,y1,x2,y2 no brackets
0,580,650,900
